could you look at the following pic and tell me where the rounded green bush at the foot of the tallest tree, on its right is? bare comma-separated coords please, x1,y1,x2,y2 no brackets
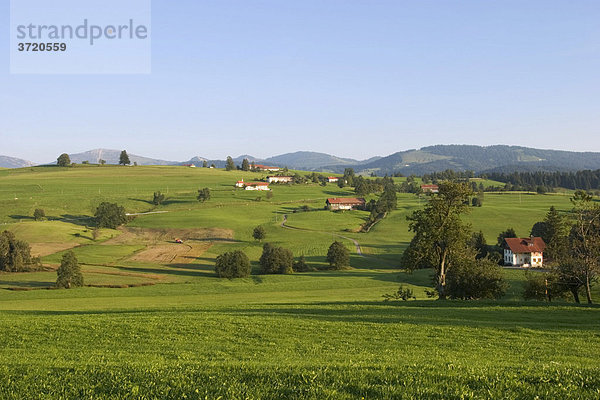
446,258,508,300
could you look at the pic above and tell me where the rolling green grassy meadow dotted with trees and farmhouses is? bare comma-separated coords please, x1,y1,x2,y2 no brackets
0,166,600,399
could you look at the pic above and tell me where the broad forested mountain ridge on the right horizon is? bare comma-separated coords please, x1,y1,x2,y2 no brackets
326,145,600,175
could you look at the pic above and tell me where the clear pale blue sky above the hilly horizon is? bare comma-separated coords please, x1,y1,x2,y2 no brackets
0,0,600,162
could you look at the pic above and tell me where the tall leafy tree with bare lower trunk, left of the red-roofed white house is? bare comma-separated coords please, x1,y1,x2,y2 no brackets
402,182,472,299
